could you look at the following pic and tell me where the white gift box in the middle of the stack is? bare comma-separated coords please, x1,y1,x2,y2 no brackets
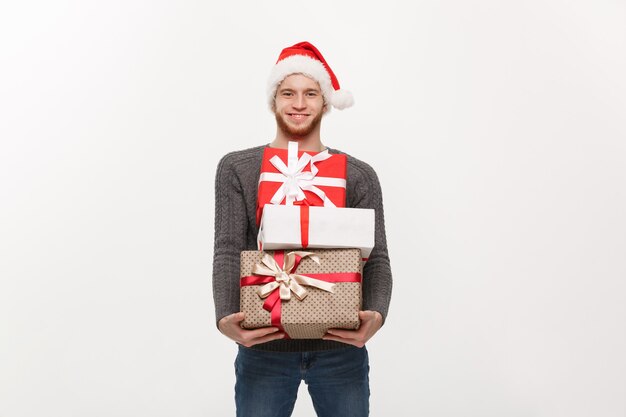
257,204,375,258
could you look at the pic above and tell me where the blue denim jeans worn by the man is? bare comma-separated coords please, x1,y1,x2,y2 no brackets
235,346,370,417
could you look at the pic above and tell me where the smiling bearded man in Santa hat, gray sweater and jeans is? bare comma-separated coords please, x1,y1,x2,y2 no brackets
213,42,392,417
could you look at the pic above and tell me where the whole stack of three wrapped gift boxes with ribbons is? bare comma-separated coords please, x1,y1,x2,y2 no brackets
240,142,374,339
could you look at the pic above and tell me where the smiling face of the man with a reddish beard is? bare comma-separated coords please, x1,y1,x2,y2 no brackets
274,74,326,138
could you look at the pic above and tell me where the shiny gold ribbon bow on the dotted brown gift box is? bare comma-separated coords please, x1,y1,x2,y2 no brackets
252,251,335,300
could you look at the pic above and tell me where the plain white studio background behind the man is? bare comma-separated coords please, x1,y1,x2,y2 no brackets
0,0,626,417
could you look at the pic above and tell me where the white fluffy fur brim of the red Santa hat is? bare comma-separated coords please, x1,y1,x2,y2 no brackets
267,55,334,109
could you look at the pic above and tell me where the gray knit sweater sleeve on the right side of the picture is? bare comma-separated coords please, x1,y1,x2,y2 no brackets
348,158,392,322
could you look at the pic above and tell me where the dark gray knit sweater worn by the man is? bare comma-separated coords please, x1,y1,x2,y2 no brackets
213,146,392,352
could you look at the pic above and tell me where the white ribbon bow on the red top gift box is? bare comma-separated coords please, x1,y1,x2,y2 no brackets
259,142,346,207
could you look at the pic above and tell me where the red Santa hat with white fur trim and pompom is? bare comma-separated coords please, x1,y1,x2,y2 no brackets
267,42,354,110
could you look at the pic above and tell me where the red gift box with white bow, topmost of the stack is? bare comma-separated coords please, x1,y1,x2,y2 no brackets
256,142,347,225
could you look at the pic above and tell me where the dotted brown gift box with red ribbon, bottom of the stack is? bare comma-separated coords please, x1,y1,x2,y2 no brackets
240,249,362,339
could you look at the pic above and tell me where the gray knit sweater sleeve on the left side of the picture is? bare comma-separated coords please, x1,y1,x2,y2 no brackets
213,154,247,324
